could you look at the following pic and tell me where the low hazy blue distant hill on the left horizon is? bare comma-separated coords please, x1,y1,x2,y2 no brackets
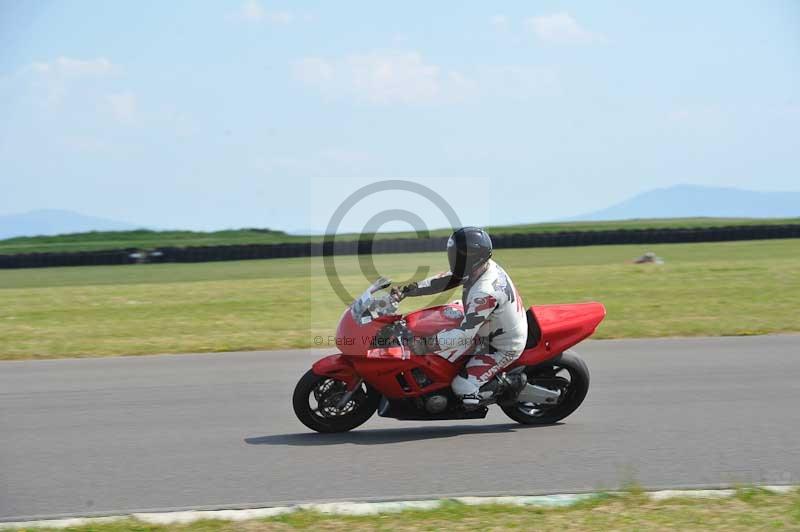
0,209,137,239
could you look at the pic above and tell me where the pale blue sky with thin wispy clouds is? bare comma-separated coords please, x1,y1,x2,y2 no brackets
0,0,800,231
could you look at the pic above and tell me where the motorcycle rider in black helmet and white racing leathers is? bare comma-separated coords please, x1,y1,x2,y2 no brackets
392,227,528,406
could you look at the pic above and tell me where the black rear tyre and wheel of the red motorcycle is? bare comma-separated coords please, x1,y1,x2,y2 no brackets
500,351,589,425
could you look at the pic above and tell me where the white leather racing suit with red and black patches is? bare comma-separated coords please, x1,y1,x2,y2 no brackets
408,259,528,397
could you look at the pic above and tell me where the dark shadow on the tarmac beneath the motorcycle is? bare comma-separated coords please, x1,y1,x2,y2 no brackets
244,423,562,446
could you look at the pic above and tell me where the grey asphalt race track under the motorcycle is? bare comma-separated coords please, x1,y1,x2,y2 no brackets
0,335,800,521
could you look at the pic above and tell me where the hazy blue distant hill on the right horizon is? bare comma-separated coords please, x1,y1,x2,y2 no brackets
572,185,800,220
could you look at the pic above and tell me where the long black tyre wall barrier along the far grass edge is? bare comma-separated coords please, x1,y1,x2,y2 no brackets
0,224,800,269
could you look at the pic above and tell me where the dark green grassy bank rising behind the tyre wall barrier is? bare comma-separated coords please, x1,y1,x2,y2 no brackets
0,218,800,254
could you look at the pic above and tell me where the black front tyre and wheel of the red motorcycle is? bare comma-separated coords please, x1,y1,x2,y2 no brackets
292,370,380,432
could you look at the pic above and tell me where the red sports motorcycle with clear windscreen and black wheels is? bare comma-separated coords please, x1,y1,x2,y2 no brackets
292,278,606,432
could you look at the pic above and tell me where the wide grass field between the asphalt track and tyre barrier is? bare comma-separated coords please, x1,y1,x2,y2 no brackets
0,240,800,359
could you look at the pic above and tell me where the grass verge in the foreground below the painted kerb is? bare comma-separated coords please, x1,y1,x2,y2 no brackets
15,488,800,532
